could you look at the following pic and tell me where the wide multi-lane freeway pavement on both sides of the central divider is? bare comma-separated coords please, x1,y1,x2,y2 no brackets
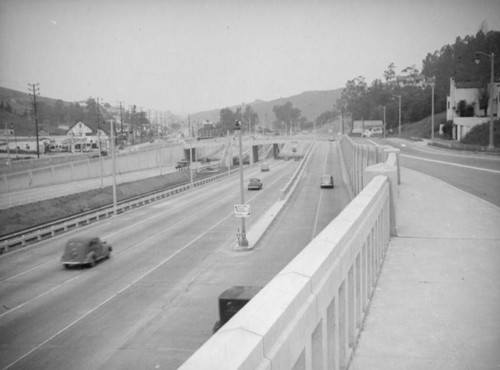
0,142,349,369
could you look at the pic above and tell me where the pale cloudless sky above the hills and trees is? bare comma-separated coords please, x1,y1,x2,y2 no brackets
0,0,500,114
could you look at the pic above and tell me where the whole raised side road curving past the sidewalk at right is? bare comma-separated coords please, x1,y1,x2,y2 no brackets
368,138,500,206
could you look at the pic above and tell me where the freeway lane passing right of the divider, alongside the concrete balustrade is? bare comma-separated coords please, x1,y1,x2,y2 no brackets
97,143,349,369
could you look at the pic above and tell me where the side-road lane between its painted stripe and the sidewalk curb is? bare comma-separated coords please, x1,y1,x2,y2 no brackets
401,156,500,206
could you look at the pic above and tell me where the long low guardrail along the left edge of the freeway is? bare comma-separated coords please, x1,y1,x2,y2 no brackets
0,171,228,255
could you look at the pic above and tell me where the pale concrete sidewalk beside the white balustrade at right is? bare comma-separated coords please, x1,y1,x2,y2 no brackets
349,168,500,370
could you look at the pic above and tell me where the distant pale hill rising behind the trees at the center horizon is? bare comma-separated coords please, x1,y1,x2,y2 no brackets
190,88,343,128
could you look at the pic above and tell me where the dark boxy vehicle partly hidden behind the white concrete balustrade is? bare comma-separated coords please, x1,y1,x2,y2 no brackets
213,285,261,333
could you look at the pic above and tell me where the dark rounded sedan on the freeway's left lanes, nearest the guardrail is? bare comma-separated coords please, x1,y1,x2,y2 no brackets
61,237,113,268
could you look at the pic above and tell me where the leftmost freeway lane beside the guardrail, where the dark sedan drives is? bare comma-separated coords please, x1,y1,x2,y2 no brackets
0,162,293,313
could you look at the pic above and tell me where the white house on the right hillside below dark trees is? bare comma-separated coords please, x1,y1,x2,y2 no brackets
446,78,500,141
